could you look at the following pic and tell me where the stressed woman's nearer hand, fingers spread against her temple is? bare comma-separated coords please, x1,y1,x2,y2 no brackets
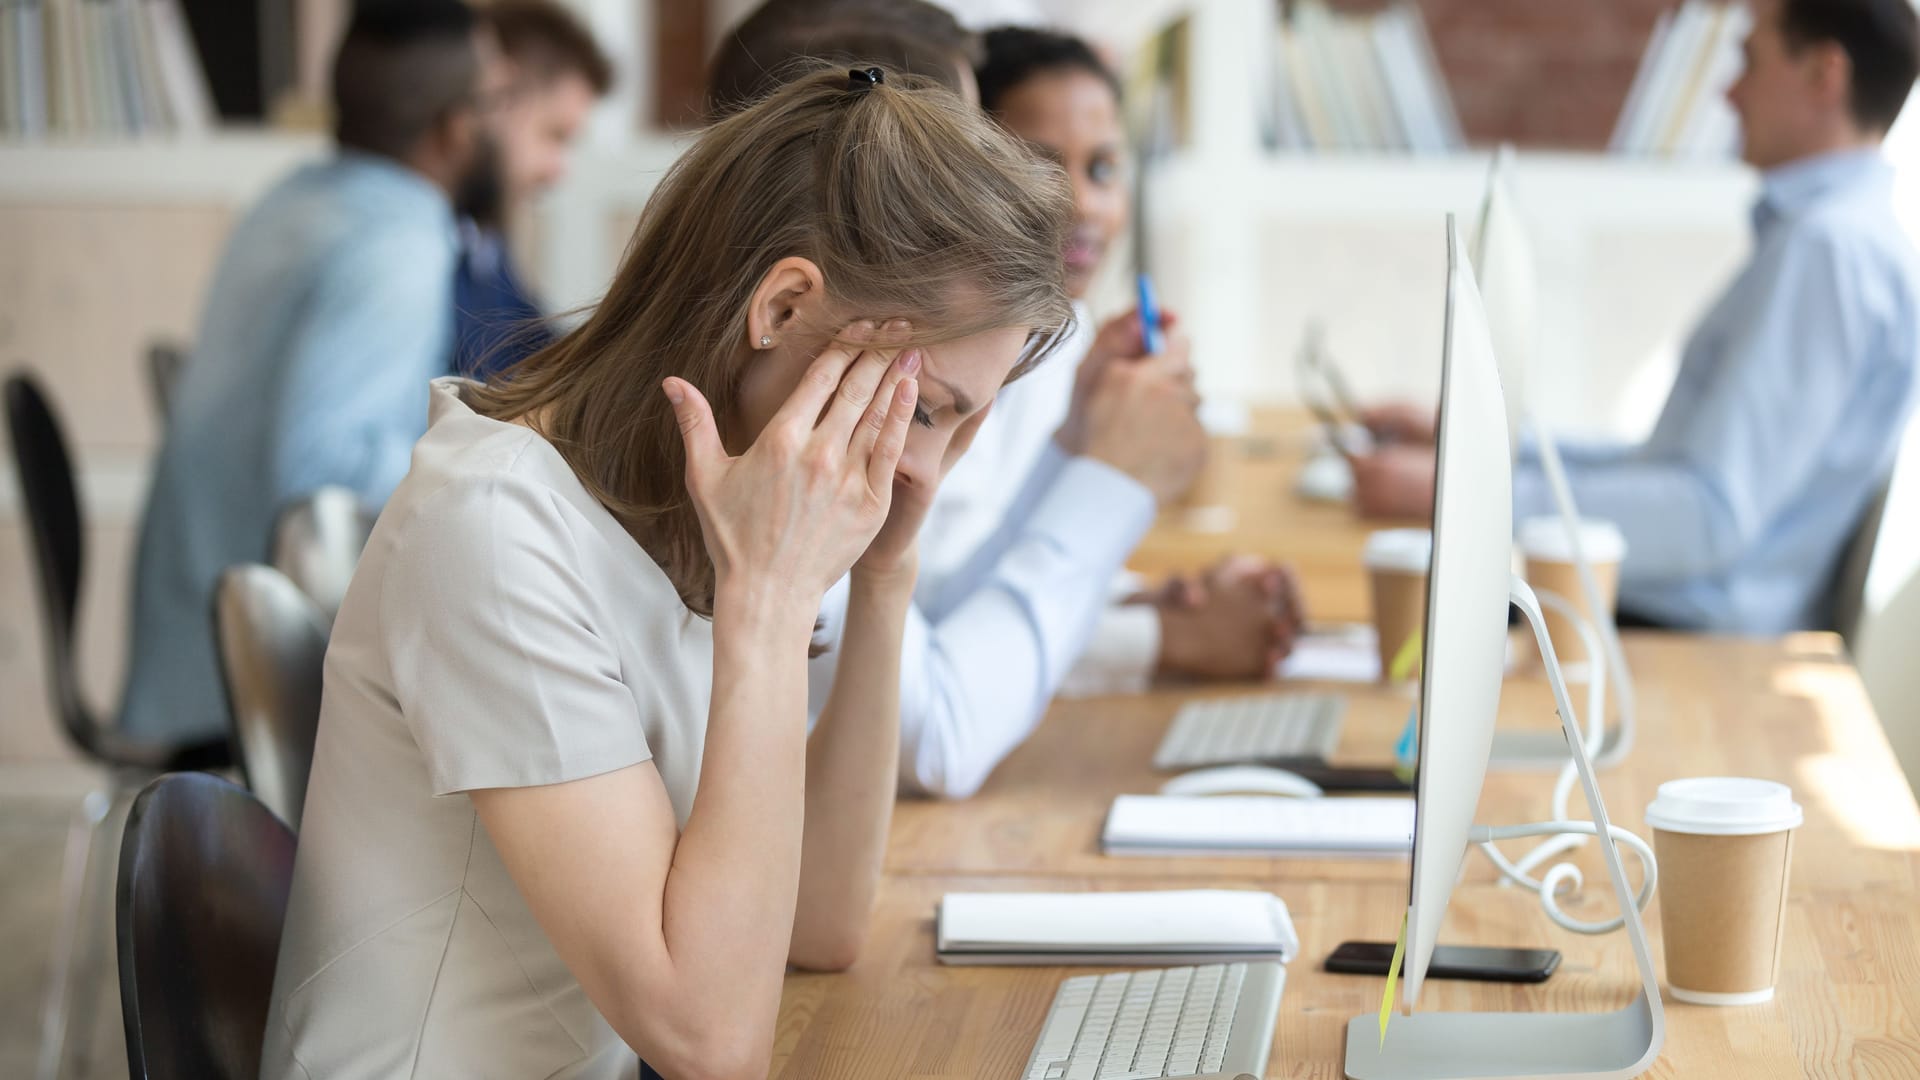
662,325,920,617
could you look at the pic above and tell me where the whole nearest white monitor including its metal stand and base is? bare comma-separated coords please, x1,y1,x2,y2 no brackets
1344,217,1665,1080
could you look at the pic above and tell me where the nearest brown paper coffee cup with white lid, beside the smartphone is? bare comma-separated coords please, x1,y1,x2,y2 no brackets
1647,776,1803,1005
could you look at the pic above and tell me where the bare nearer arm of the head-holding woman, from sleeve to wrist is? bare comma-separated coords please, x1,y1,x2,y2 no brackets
472,596,812,1080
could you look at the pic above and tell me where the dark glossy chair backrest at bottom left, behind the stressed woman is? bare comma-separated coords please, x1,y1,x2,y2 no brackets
113,773,294,1080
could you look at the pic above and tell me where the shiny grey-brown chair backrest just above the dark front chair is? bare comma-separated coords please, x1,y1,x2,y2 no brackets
213,563,326,830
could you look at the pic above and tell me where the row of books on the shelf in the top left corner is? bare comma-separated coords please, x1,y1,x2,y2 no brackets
0,0,215,138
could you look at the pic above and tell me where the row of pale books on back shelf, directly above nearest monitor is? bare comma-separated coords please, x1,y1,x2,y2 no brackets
1267,0,1467,154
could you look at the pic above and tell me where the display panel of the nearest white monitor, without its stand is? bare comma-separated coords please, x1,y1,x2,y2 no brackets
1405,217,1513,1009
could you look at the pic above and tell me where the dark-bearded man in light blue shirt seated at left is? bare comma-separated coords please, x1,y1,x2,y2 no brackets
121,0,499,738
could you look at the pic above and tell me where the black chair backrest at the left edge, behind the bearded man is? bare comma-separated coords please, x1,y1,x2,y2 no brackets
6,371,98,737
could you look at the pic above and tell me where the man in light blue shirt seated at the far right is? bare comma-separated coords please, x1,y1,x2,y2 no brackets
1354,0,1920,634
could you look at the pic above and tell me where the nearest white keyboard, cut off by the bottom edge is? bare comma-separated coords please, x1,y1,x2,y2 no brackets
1021,961,1286,1080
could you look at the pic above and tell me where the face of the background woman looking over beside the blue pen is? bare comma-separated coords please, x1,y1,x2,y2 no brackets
998,67,1127,298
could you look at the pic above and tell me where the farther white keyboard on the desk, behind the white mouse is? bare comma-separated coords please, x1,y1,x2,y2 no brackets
1154,694,1346,771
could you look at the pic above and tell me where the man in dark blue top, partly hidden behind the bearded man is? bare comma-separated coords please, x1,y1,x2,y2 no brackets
451,0,612,379
